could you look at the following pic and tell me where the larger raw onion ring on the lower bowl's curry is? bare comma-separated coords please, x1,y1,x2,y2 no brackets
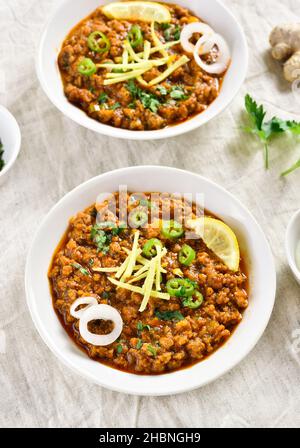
79,304,123,346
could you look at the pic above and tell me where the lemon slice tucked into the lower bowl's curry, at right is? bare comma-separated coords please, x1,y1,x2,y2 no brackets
188,216,240,271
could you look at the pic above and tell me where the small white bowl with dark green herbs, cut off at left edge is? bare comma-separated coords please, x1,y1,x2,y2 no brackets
0,105,21,185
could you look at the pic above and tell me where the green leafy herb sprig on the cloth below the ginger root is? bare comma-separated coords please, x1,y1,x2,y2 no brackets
244,94,300,176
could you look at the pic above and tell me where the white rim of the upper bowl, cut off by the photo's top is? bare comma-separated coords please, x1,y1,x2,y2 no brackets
35,0,249,140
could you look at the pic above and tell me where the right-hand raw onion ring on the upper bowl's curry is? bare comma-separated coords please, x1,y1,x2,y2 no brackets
194,33,230,74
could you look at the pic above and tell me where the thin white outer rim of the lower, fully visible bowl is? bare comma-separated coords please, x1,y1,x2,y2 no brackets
25,165,276,396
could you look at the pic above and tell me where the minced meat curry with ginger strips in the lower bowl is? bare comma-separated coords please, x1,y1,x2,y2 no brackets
49,193,248,374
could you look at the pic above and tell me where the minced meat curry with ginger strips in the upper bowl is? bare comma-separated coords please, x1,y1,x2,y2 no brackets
58,4,225,131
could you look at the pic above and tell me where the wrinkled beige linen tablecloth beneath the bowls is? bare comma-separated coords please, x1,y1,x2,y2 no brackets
0,0,300,427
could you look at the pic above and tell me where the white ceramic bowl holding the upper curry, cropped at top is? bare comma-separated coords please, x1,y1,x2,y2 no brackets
36,0,248,140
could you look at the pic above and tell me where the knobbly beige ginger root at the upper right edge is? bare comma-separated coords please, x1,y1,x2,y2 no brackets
270,23,300,82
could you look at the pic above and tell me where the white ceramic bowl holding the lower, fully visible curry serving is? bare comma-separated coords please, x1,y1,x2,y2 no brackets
25,166,276,395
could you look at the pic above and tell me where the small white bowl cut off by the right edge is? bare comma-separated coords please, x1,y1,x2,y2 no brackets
285,210,300,284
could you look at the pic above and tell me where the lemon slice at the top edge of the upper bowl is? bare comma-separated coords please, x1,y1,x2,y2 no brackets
102,1,171,23
